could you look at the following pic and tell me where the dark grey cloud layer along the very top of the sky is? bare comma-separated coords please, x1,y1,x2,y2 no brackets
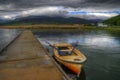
0,0,120,8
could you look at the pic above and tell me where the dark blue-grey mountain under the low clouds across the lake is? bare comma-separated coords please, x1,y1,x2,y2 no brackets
1,16,94,25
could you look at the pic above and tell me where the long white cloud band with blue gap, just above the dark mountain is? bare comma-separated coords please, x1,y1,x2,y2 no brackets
2,6,118,20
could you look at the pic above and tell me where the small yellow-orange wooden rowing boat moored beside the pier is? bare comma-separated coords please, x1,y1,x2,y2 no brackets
53,44,86,75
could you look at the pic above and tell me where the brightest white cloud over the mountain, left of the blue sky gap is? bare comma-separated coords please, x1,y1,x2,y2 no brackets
21,6,65,16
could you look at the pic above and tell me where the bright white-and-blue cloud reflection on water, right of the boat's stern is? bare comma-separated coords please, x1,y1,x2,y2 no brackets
68,35,119,47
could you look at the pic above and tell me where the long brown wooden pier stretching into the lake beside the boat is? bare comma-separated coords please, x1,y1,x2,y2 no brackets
0,30,70,80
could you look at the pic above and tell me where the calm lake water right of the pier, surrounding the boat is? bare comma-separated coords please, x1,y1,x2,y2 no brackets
35,31,120,80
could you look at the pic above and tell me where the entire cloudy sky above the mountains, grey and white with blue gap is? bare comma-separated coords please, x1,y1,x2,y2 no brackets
0,0,120,20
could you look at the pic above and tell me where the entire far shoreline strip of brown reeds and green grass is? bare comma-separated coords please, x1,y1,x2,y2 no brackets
0,24,120,31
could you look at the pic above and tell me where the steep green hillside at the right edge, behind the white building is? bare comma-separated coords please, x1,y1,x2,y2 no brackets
104,15,120,26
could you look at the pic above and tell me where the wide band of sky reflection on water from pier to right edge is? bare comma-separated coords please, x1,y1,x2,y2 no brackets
37,32,120,47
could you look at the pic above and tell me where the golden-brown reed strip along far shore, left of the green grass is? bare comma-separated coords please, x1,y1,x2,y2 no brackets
0,24,83,29
